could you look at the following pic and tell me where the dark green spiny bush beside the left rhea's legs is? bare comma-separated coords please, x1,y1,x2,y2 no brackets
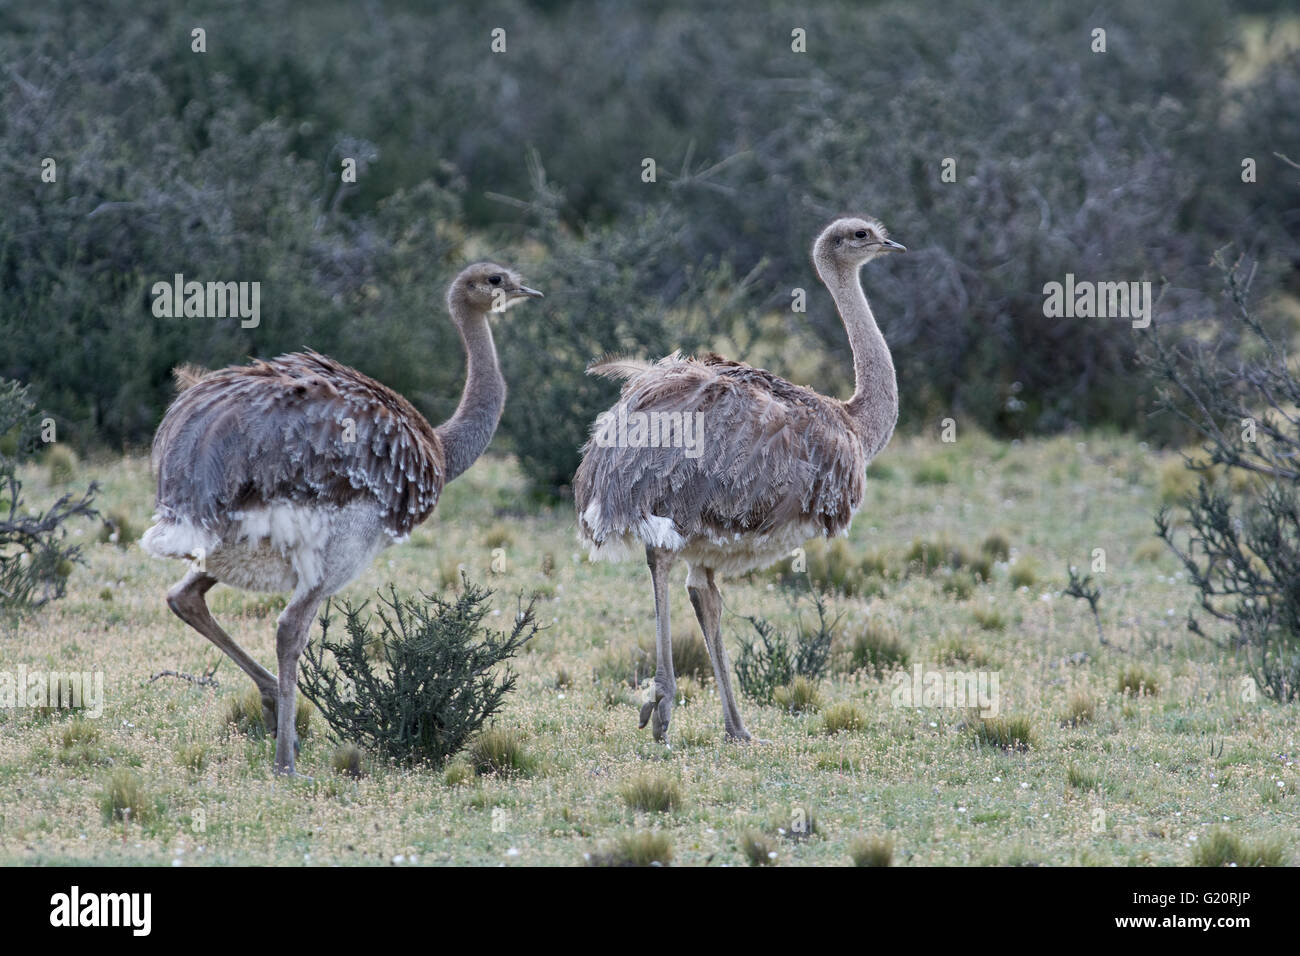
299,579,538,766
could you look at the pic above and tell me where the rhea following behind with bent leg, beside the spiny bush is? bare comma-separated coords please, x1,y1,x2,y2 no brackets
140,263,542,774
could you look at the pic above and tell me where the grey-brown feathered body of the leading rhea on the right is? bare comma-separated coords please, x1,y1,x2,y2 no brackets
573,354,867,544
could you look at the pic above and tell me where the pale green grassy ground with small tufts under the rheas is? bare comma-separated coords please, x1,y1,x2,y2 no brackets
0,436,1297,865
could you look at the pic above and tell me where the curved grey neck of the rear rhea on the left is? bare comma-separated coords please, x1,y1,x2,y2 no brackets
434,306,506,481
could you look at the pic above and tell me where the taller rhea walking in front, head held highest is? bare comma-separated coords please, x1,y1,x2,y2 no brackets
573,217,905,743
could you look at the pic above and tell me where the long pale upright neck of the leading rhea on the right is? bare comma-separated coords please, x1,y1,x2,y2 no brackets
822,261,898,455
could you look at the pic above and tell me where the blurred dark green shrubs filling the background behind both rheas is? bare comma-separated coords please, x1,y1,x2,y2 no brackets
0,0,1300,490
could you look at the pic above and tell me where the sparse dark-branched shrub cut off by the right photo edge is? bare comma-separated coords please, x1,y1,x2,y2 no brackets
1154,267,1300,701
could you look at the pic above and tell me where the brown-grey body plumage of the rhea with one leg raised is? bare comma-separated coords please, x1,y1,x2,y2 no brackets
152,350,445,537
